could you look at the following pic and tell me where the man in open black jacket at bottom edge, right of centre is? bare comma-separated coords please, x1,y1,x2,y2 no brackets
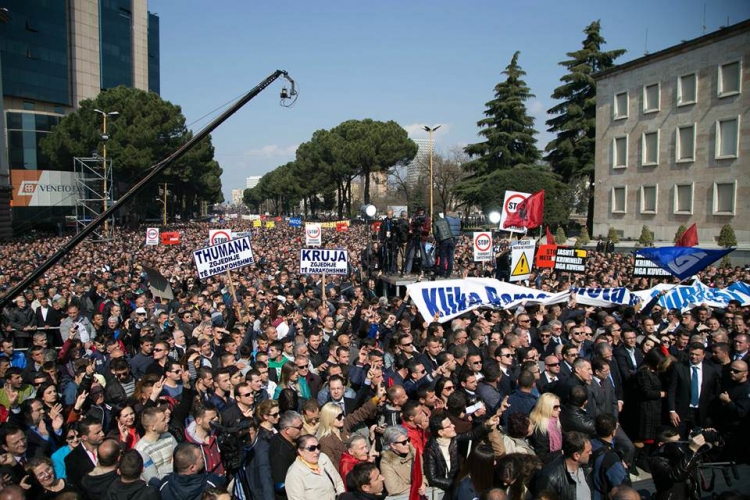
531,432,591,500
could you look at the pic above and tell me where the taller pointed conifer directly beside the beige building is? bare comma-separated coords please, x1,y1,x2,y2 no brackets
545,21,625,231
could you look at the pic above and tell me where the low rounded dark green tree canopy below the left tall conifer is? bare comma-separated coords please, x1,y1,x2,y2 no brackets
456,167,573,226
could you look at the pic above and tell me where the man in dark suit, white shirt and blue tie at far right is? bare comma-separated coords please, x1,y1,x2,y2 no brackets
667,342,721,436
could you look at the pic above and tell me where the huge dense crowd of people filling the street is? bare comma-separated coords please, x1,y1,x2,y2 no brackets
0,214,750,500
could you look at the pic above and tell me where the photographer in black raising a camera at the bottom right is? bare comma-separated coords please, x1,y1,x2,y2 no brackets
648,427,720,500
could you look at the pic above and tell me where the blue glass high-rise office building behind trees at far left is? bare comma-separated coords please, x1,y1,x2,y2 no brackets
0,0,160,230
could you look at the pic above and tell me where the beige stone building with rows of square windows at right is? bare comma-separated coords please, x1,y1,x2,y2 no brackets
593,21,750,243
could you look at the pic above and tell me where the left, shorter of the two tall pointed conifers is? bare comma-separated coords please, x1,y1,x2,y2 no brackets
464,52,541,178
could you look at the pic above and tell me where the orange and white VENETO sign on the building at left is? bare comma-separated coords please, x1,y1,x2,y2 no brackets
10,170,80,207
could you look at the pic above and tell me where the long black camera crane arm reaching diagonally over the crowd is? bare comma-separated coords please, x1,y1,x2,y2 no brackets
0,69,297,310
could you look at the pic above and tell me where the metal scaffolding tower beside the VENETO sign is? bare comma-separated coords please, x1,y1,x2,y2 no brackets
73,156,115,241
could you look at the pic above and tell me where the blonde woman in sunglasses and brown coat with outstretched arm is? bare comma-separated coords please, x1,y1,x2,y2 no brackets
316,396,380,470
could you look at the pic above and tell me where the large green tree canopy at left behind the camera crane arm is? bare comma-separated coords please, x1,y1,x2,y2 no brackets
41,86,224,214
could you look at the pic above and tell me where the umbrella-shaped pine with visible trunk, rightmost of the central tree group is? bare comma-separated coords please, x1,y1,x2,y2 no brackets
331,118,418,203
